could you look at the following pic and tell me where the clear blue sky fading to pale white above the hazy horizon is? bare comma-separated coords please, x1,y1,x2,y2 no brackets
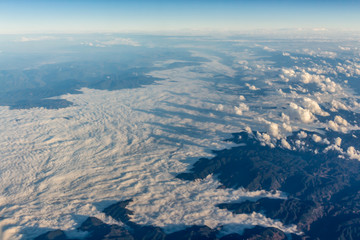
0,0,360,34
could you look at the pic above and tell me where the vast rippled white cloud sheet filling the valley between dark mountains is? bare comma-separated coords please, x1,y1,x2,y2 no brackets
0,61,296,239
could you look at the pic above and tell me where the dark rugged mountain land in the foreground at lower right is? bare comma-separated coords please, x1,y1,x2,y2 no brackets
36,131,360,240
